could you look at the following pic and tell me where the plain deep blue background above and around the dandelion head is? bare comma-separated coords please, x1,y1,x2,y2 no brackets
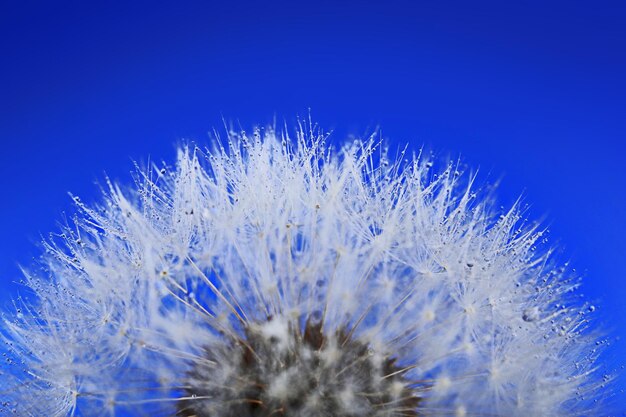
0,0,626,410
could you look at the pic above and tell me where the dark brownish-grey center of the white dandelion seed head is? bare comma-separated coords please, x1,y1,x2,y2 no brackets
176,318,420,417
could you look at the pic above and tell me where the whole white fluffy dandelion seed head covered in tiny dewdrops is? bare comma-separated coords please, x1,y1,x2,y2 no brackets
0,127,603,417
